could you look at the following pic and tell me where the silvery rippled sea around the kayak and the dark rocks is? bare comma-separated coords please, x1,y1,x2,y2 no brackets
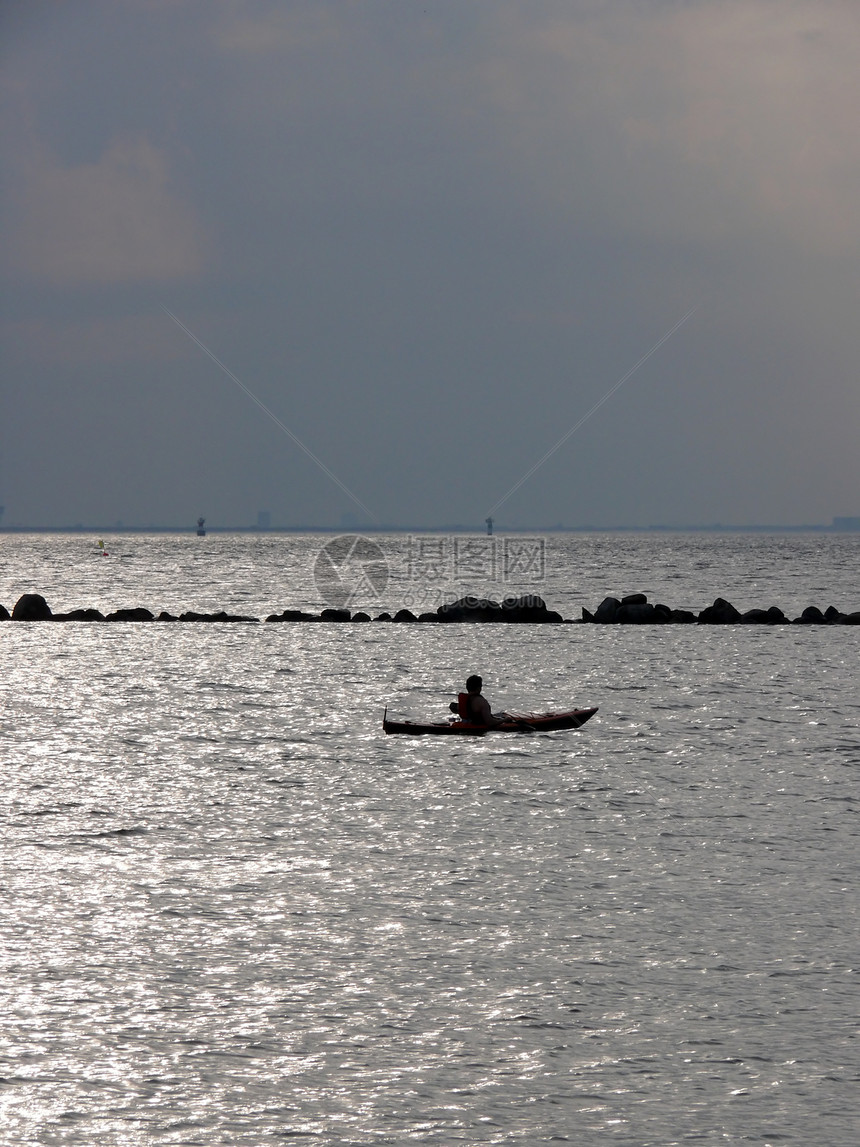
0,531,860,1147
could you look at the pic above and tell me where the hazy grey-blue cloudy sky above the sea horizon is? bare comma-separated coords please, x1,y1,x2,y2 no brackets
0,0,860,529
